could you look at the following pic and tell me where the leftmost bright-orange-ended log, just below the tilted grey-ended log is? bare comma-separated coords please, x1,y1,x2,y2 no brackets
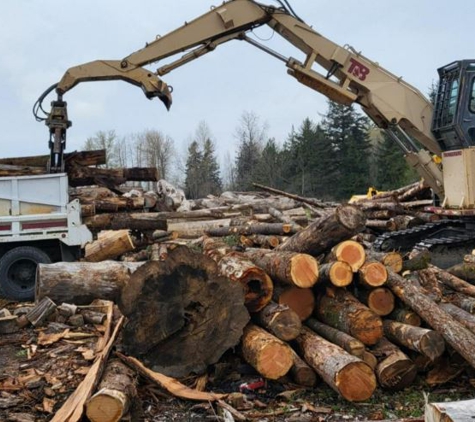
245,249,319,288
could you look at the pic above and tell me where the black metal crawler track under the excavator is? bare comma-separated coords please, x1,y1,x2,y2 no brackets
374,219,475,268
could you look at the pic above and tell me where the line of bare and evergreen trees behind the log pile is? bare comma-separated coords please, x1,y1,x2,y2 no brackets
84,101,418,201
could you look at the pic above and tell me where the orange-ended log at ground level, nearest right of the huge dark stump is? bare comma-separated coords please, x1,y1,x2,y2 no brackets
242,324,294,380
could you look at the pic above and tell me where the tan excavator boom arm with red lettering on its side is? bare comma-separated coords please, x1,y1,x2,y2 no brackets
53,0,443,196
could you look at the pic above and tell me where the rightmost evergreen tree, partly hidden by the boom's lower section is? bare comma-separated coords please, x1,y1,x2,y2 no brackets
375,133,418,190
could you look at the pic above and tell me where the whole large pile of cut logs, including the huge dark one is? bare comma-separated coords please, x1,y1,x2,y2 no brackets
0,161,475,420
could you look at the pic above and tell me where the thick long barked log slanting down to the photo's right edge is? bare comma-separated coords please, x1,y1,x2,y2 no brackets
388,272,475,367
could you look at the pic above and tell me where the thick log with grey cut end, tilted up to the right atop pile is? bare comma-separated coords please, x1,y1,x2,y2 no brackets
276,205,365,256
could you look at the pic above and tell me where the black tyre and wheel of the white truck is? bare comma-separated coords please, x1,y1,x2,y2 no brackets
0,246,51,301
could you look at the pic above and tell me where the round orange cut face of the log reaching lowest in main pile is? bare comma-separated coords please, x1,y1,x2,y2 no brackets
335,361,376,401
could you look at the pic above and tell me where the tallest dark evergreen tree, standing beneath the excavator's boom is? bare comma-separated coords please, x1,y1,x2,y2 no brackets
323,101,371,200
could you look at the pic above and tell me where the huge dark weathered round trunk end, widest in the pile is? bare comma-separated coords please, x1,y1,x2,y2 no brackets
119,247,249,377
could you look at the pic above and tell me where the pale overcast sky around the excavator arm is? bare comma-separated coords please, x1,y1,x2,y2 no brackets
0,0,475,168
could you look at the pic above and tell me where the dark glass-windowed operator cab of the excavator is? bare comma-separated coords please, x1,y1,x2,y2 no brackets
432,60,475,151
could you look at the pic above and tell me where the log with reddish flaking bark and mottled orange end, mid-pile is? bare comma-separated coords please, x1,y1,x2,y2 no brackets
315,289,383,345
